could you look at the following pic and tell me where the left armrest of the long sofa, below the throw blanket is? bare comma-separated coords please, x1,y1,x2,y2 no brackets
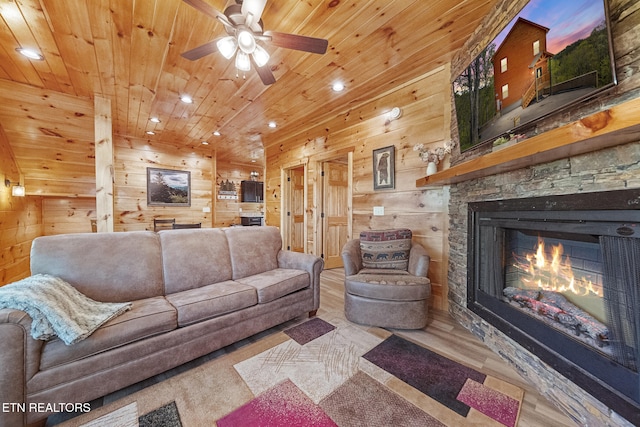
0,309,43,426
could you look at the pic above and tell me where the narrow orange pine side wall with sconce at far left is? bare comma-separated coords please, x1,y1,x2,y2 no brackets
0,123,42,286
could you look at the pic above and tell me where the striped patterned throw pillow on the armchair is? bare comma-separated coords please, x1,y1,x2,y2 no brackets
360,228,411,270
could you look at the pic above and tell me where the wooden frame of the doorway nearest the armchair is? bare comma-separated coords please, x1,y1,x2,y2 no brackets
313,147,355,264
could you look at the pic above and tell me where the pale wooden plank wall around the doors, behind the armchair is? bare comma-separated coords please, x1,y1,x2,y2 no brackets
265,67,451,309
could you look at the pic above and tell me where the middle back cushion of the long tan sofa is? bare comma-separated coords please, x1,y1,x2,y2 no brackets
158,228,231,295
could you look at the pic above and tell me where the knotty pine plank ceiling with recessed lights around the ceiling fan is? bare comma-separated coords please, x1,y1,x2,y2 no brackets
0,0,497,192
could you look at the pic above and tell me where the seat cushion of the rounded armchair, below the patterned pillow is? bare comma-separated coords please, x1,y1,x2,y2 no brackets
344,274,431,301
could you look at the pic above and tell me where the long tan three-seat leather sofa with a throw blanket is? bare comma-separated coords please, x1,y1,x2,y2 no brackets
0,227,323,426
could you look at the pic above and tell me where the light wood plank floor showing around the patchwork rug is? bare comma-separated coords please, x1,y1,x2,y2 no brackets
46,268,576,427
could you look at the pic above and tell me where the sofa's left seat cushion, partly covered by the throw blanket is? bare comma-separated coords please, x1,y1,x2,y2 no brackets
40,297,177,370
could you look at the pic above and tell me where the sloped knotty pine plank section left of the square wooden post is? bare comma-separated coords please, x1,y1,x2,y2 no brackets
0,79,96,197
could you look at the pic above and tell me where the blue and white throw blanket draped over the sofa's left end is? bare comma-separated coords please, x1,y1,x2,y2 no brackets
0,274,131,345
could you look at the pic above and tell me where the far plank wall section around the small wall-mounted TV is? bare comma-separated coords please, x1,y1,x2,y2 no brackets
214,163,264,227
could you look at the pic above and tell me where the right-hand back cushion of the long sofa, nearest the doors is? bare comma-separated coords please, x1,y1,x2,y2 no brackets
224,226,282,280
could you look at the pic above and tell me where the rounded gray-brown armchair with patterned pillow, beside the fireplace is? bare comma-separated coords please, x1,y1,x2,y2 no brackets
342,229,431,329
